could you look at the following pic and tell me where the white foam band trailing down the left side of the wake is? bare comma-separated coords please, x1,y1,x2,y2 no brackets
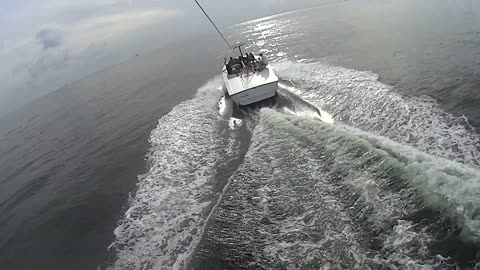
110,80,242,269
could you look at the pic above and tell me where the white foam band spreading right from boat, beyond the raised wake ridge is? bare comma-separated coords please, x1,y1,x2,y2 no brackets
275,61,480,168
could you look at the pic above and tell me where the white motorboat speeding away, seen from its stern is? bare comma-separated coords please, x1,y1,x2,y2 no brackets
222,43,278,105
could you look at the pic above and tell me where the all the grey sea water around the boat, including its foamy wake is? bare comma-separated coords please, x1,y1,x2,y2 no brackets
0,0,480,269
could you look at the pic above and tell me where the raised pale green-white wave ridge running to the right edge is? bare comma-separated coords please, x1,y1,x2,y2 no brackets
343,123,480,240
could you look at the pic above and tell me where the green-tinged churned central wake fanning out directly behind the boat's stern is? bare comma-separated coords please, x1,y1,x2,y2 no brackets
194,109,480,269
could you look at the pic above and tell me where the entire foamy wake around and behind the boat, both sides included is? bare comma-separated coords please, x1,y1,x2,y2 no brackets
106,62,480,269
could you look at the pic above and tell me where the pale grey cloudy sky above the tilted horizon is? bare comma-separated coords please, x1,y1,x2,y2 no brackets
0,0,329,116
